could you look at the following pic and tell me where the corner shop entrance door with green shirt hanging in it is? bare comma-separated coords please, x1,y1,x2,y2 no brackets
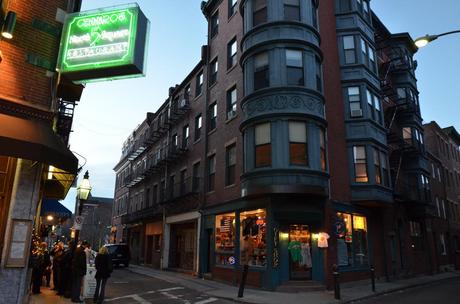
288,225,312,280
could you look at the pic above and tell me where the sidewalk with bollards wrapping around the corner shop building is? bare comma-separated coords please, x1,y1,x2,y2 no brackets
129,265,460,304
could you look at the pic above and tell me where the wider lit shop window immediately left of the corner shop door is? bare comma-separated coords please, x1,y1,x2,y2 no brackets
240,209,267,267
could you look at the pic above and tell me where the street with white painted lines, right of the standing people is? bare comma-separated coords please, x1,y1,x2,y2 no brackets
104,268,235,304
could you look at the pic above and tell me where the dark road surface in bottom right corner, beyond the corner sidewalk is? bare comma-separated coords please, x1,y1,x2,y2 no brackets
353,279,460,304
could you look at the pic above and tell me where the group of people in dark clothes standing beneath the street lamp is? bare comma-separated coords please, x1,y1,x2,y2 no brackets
31,241,113,303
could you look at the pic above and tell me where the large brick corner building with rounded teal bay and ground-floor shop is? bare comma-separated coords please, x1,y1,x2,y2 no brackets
113,0,460,290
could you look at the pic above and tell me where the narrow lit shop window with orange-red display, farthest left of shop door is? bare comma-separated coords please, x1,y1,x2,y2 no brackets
215,213,236,265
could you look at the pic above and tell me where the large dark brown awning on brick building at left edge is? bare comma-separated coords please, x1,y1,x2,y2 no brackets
0,114,78,174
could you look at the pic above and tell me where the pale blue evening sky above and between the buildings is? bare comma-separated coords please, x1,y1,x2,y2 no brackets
64,0,460,211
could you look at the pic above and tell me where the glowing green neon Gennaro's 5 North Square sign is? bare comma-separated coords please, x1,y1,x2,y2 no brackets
57,4,149,82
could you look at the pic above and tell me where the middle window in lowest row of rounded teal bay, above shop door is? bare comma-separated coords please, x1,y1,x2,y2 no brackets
289,121,308,166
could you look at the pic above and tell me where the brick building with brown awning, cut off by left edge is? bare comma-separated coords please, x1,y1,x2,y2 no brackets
0,0,83,303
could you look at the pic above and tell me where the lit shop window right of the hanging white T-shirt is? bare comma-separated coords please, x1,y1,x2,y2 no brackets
335,212,369,267
